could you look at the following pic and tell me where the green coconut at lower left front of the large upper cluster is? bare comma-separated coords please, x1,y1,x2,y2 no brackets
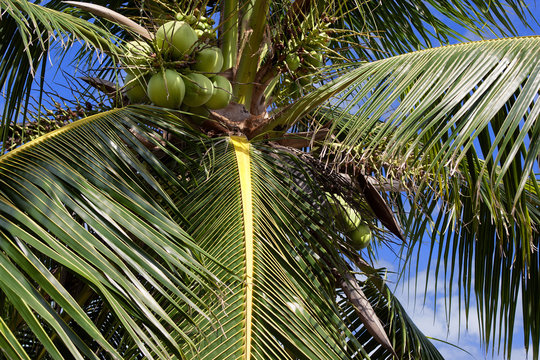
147,69,186,109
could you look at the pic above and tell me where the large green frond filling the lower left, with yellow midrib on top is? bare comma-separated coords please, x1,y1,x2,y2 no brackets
0,108,220,359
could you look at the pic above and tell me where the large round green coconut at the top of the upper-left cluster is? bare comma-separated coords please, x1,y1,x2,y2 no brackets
155,21,198,59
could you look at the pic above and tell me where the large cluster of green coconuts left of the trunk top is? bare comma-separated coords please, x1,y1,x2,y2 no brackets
124,13,232,110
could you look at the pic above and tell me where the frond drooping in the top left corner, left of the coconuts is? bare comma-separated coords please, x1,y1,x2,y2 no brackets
0,0,125,152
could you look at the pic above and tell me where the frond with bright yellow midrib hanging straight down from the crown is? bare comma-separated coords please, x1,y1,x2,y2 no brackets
171,139,368,359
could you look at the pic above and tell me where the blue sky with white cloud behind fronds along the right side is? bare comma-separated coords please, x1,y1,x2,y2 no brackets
377,4,540,360
